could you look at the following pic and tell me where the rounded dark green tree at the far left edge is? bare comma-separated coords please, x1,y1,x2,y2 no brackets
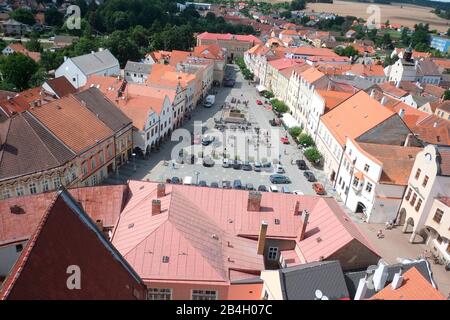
0,54,39,91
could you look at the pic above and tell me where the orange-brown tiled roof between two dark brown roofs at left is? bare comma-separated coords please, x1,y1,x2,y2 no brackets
30,95,114,154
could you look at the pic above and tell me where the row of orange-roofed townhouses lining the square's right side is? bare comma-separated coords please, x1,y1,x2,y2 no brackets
245,41,450,259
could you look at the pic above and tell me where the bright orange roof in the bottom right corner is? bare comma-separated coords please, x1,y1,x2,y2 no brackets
370,267,446,300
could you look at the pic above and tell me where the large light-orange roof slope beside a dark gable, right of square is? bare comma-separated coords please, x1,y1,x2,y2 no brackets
321,91,394,146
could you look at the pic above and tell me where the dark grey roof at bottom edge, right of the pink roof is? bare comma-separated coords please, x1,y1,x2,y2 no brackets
279,261,349,300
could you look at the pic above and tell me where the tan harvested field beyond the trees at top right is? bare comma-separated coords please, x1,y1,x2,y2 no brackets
306,0,450,32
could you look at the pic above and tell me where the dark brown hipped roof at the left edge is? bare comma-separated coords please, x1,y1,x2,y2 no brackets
0,112,75,179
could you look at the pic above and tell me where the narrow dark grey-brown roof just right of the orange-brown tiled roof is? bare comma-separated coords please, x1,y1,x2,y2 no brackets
74,87,132,132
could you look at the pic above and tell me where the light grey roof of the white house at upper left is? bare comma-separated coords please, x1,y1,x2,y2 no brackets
71,49,119,75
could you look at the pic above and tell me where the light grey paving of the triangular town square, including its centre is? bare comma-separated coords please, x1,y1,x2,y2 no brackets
119,65,323,194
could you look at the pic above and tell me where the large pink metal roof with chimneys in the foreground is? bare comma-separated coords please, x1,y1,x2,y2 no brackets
112,181,374,281
